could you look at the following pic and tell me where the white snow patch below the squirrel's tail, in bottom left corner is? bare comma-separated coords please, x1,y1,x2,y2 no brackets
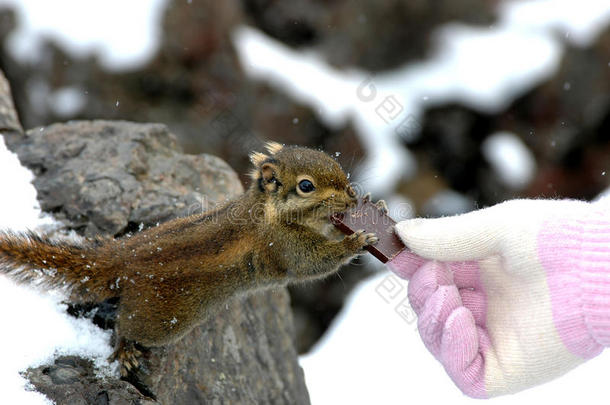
0,277,113,404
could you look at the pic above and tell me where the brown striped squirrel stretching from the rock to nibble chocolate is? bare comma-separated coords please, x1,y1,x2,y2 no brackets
0,142,385,377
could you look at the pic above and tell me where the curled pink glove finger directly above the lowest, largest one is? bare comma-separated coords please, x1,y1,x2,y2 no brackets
417,285,462,359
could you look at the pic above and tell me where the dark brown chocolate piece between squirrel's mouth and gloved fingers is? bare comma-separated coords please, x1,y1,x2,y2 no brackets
330,196,406,263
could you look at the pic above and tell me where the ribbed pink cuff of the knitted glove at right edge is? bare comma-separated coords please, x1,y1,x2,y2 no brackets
538,199,610,359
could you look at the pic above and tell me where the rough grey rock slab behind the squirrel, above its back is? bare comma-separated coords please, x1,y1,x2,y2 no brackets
9,121,242,236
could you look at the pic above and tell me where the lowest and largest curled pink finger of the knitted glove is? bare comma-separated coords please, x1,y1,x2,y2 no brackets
440,307,491,398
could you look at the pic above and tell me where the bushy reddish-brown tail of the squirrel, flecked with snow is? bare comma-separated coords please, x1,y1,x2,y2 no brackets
0,232,116,301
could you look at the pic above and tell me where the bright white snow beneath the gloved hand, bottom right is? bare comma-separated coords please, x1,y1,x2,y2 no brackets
300,271,610,405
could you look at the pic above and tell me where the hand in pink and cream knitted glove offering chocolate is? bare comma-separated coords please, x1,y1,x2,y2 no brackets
388,200,610,398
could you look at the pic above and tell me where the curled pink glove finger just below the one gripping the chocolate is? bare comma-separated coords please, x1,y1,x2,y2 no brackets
408,261,453,315
